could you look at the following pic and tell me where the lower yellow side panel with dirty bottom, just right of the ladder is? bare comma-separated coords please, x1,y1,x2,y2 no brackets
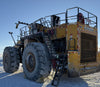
68,51,80,76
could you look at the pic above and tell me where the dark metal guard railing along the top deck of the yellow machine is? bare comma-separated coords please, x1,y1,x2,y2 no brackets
18,7,97,37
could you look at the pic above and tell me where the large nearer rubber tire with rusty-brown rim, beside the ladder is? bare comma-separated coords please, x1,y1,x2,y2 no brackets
22,42,51,81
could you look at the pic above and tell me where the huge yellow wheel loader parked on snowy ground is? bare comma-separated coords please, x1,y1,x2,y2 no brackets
3,7,100,86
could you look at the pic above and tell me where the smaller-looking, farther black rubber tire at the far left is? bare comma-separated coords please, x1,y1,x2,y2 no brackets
3,47,20,73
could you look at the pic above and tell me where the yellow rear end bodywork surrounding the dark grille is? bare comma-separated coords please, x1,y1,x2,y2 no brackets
66,23,100,76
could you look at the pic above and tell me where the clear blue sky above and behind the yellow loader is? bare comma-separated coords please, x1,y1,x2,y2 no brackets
0,0,100,56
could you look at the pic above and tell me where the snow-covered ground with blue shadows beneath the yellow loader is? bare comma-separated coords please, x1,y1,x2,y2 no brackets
0,60,100,87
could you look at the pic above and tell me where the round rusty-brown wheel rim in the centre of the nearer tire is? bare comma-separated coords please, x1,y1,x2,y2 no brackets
25,53,36,72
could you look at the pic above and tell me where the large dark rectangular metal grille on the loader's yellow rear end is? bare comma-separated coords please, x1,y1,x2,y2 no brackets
81,33,96,63
